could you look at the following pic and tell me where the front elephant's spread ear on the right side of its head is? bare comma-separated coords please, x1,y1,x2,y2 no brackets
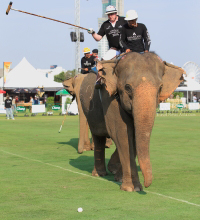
159,62,185,102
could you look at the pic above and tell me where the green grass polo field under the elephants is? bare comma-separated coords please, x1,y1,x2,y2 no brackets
0,114,200,220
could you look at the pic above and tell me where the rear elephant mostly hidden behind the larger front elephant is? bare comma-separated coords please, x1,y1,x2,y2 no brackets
64,74,112,154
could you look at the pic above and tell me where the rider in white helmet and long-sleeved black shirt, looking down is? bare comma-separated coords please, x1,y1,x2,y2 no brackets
120,10,151,53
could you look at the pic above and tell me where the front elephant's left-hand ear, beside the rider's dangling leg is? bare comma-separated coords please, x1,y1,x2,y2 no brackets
97,61,117,96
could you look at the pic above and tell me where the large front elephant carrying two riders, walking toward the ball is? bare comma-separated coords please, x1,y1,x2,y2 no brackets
64,52,183,191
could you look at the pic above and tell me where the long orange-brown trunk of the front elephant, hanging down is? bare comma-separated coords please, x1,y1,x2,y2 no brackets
133,81,157,187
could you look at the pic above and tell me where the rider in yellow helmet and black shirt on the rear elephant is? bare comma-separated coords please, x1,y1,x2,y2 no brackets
81,47,95,74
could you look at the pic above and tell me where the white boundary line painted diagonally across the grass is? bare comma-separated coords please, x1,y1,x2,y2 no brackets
0,150,200,207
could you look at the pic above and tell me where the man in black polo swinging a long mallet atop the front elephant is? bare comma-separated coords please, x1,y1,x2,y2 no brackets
88,5,126,60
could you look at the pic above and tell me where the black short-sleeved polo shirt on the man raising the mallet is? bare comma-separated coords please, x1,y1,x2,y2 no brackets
97,16,127,49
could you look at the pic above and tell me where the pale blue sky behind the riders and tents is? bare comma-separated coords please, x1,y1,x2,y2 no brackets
0,0,200,70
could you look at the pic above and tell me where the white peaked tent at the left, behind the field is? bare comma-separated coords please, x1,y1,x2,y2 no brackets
4,57,63,91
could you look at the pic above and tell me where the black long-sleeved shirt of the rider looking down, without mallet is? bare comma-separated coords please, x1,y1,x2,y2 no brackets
120,23,151,52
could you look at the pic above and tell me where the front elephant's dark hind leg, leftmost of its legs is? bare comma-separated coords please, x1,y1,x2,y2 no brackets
92,135,107,176
